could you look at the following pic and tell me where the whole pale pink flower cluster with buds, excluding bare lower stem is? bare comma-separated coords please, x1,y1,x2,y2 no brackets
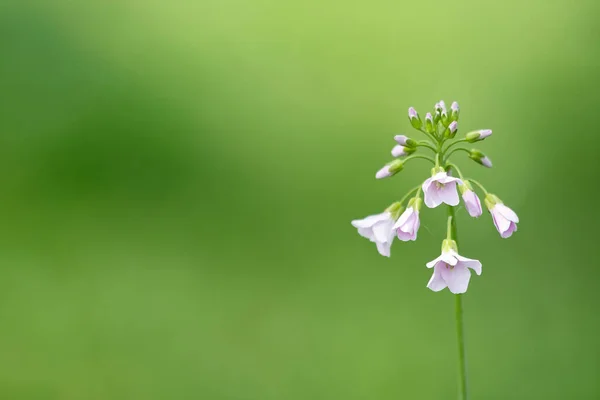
352,100,519,294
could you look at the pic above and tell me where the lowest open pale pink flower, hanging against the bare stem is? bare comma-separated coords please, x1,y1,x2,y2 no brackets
427,239,481,294
